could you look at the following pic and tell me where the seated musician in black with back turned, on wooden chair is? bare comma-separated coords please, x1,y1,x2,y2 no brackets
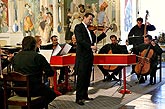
12,36,56,107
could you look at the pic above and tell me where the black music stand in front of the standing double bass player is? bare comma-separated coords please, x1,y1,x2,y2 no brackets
128,36,144,45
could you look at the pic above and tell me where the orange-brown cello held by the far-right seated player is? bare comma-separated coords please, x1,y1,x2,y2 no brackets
135,45,154,75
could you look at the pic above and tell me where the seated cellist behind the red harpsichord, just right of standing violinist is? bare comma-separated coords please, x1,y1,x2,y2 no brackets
98,35,123,82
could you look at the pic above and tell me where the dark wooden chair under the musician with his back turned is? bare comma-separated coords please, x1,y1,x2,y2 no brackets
4,71,46,109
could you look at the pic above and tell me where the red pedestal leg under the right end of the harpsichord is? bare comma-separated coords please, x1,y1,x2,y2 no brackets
119,67,131,94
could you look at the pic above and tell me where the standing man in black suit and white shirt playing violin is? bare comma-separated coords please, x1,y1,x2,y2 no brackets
74,13,109,105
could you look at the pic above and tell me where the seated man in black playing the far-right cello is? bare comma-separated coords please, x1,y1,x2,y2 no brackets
132,35,163,85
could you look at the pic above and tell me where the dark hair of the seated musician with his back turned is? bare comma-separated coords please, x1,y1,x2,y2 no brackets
22,36,36,51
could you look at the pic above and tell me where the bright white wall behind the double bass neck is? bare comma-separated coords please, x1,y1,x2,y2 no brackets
139,0,165,36
